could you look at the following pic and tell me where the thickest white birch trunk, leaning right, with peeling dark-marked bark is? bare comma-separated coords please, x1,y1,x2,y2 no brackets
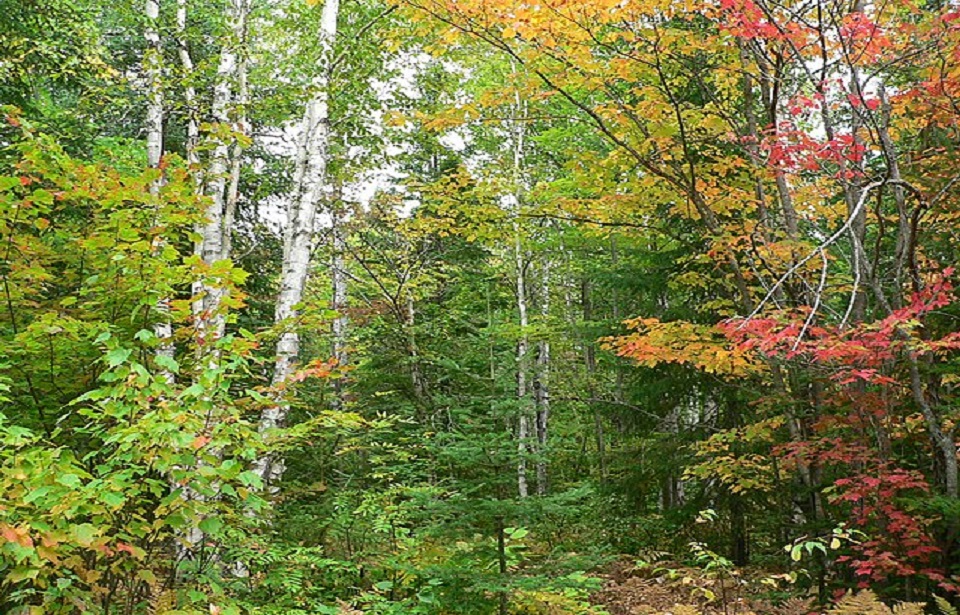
254,0,340,485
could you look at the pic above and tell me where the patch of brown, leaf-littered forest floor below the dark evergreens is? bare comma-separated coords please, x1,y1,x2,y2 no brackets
592,559,809,615
